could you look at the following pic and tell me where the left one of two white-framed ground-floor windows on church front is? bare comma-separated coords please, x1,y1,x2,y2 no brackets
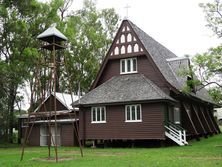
91,107,106,123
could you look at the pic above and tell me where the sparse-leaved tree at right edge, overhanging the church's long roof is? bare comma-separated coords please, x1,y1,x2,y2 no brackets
193,0,222,103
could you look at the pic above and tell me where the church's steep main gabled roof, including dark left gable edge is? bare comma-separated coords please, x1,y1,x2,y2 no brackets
91,20,213,103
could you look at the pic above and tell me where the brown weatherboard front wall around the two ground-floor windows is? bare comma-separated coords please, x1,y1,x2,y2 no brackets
80,103,165,140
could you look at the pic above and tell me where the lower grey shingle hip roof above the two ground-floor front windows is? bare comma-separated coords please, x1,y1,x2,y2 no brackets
74,74,175,105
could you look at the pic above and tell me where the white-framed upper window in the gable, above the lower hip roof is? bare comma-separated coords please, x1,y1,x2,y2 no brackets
120,58,137,74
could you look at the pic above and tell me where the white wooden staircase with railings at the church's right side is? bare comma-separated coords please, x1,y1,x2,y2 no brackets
165,122,188,146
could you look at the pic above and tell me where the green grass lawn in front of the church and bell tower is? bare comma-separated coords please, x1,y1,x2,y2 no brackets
0,134,222,167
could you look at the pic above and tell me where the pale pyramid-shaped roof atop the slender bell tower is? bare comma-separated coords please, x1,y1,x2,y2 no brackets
37,24,67,43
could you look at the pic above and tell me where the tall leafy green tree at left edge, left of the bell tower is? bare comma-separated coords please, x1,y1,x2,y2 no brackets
0,0,60,142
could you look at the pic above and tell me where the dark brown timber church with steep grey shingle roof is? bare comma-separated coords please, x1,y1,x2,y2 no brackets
73,20,220,146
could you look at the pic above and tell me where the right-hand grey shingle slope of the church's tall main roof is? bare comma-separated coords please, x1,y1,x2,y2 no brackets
128,21,213,103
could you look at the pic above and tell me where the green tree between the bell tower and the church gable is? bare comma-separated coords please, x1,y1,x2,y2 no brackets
61,0,119,93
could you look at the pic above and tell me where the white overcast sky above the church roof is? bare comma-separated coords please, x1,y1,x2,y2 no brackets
22,0,221,108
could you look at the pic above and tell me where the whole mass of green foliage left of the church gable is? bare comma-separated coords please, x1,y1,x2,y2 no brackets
0,0,118,142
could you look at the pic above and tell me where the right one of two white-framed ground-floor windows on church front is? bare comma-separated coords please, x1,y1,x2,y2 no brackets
125,104,142,122
